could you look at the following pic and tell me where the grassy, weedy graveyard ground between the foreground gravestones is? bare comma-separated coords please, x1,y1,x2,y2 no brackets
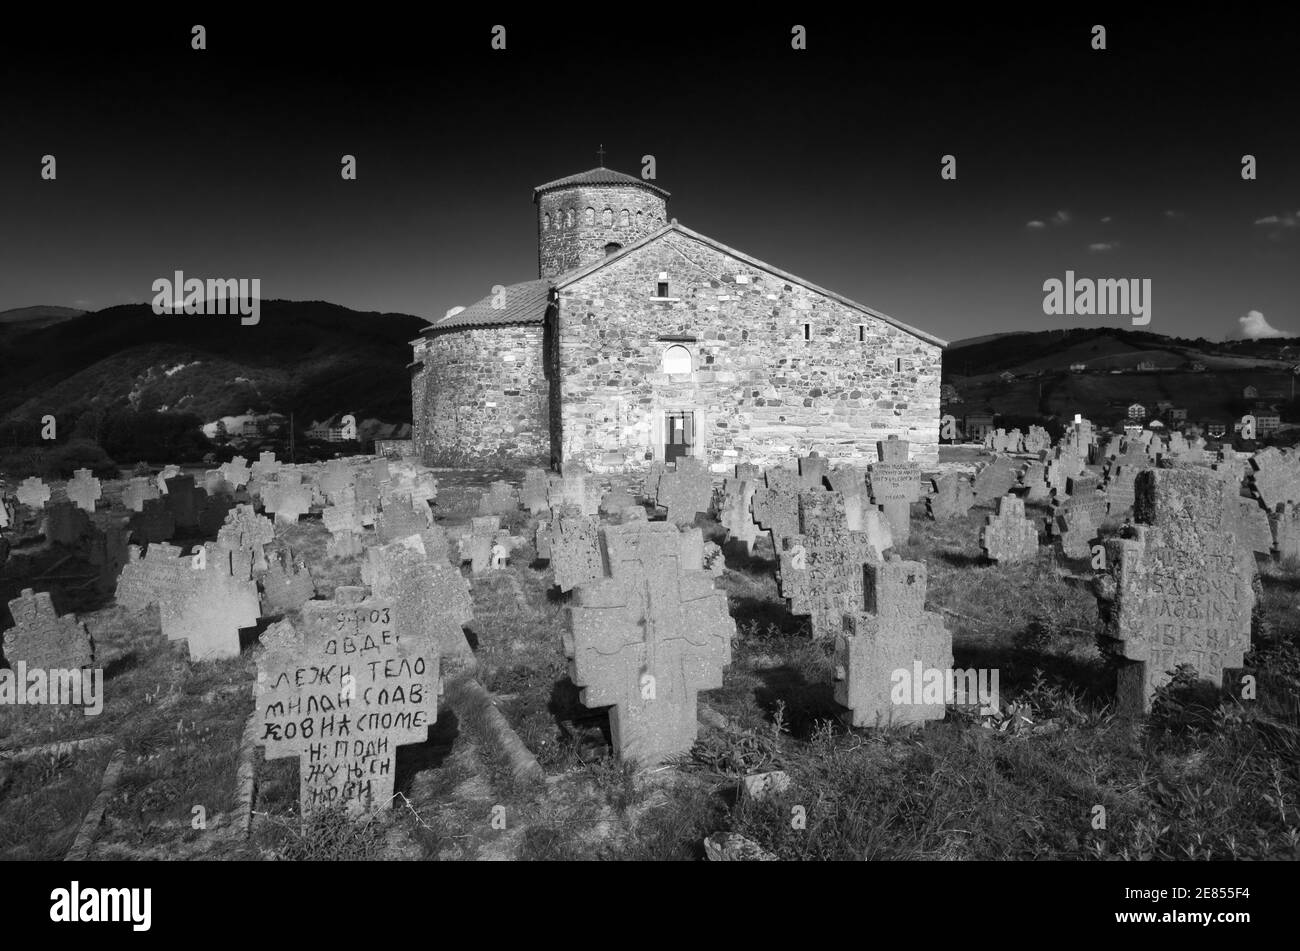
0,459,1300,860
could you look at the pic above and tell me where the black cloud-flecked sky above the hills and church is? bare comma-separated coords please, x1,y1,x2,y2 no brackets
0,12,1300,339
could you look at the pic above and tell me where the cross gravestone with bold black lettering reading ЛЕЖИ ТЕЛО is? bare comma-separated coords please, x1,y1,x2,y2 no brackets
256,587,441,818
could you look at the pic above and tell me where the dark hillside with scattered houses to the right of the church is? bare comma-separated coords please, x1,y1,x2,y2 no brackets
944,327,1300,422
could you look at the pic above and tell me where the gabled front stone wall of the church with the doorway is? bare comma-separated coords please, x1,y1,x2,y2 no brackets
553,233,941,472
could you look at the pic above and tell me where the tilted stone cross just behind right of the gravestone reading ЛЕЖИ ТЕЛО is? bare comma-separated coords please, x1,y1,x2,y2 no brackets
361,537,475,661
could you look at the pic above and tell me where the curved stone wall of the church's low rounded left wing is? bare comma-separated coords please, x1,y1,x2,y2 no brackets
411,323,551,465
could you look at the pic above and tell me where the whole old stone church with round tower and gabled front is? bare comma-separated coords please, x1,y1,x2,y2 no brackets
411,168,945,473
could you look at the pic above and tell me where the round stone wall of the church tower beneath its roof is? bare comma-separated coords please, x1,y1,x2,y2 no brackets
537,184,668,277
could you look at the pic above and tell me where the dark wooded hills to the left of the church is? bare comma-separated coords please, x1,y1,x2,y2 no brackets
0,300,428,422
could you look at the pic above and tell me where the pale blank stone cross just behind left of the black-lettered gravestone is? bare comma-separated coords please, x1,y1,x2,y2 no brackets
159,542,260,661
